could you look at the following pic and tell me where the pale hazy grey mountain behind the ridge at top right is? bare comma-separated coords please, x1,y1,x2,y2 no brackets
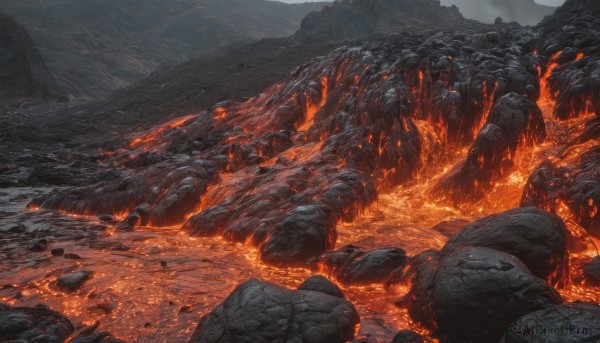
442,0,556,25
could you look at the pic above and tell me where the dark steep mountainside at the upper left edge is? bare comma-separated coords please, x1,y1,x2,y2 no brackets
0,11,59,103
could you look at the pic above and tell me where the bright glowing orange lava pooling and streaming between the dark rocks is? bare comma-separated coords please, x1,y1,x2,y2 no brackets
0,53,600,343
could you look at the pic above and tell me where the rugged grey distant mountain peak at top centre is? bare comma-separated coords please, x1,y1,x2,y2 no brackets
297,0,465,41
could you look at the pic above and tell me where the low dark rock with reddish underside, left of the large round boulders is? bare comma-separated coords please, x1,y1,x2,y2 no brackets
316,245,407,285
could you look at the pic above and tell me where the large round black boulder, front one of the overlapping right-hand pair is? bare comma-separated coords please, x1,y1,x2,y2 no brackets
406,247,561,343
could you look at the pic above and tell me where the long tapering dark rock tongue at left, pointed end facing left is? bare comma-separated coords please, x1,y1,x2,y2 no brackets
33,158,215,227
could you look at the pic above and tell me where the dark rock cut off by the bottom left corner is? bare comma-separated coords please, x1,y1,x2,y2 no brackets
0,303,74,343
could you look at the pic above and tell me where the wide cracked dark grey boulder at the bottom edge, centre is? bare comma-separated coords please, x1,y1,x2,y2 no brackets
189,280,360,343
